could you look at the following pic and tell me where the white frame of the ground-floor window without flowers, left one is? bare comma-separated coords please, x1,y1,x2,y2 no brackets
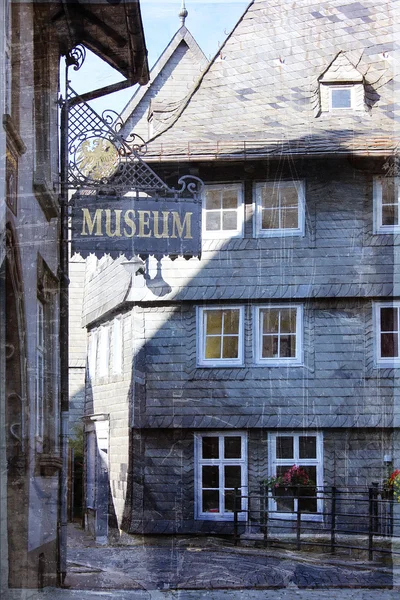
194,431,248,521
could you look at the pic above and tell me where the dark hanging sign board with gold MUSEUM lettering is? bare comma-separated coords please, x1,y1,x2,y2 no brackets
71,194,201,259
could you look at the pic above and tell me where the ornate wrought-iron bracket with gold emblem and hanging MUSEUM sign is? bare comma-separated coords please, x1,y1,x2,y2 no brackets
63,46,203,258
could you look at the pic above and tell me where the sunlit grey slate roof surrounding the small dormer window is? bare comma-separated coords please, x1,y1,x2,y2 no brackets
146,0,400,160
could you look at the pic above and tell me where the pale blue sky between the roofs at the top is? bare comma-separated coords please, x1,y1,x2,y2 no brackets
70,0,250,113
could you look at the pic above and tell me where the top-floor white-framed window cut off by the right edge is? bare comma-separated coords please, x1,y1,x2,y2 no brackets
373,177,400,233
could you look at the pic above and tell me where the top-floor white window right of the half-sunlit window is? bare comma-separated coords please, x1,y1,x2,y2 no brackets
255,181,305,237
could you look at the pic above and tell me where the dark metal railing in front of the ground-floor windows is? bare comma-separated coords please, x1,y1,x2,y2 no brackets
233,484,400,560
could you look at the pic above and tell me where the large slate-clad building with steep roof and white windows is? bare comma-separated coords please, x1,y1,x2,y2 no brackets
84,0,400,533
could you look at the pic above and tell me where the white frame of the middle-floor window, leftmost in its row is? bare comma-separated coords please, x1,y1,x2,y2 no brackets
197,305,244,367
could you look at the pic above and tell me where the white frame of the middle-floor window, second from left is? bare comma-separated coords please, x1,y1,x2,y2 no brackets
253,304,304,367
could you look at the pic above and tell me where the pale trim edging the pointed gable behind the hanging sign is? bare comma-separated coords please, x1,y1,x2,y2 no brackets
121,25,208,122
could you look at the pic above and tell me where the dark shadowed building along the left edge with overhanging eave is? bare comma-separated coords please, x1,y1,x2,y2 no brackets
0,0,148,597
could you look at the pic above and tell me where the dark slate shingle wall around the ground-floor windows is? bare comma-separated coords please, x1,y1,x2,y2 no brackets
130,429,391,534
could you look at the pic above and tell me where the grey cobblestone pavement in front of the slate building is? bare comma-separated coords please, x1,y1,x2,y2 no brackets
58,525,400,600
